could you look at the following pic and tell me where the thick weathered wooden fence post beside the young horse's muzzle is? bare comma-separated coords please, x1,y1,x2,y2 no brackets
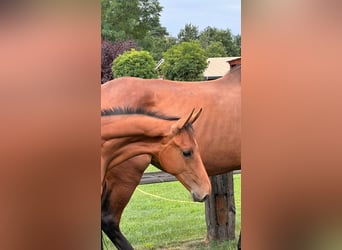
205,172,236,241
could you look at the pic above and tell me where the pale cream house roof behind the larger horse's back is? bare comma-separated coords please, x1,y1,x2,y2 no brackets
203,57,240,78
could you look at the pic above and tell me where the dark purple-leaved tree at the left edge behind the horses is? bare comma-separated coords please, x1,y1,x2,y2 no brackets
101,40,138,83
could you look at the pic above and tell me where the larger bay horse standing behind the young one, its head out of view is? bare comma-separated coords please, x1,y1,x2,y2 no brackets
101,66,241,249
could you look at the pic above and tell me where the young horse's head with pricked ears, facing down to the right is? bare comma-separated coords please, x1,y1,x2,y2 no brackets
159,109,211,202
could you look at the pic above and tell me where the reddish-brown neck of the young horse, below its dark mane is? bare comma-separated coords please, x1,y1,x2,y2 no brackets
101,115,175,166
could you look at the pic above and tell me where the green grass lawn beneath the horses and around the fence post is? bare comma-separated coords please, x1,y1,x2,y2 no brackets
104,167,241,250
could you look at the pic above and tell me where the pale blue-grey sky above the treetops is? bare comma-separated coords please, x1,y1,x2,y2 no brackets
159,0,241,37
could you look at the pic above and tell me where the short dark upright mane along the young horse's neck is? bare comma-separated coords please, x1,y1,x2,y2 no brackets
101,107,180,121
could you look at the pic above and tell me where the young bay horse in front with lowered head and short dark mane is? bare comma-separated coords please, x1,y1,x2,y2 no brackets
101,107,211,202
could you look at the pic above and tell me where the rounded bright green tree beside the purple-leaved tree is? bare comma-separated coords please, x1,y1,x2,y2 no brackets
112,49,158,79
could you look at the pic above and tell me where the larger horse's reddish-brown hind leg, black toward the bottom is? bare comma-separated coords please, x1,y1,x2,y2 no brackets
101,155,151,250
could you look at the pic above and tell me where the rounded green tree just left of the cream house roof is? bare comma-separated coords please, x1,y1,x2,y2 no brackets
162,41,207,81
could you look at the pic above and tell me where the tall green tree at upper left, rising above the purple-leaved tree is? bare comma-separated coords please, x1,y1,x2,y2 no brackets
101,0,162,42
